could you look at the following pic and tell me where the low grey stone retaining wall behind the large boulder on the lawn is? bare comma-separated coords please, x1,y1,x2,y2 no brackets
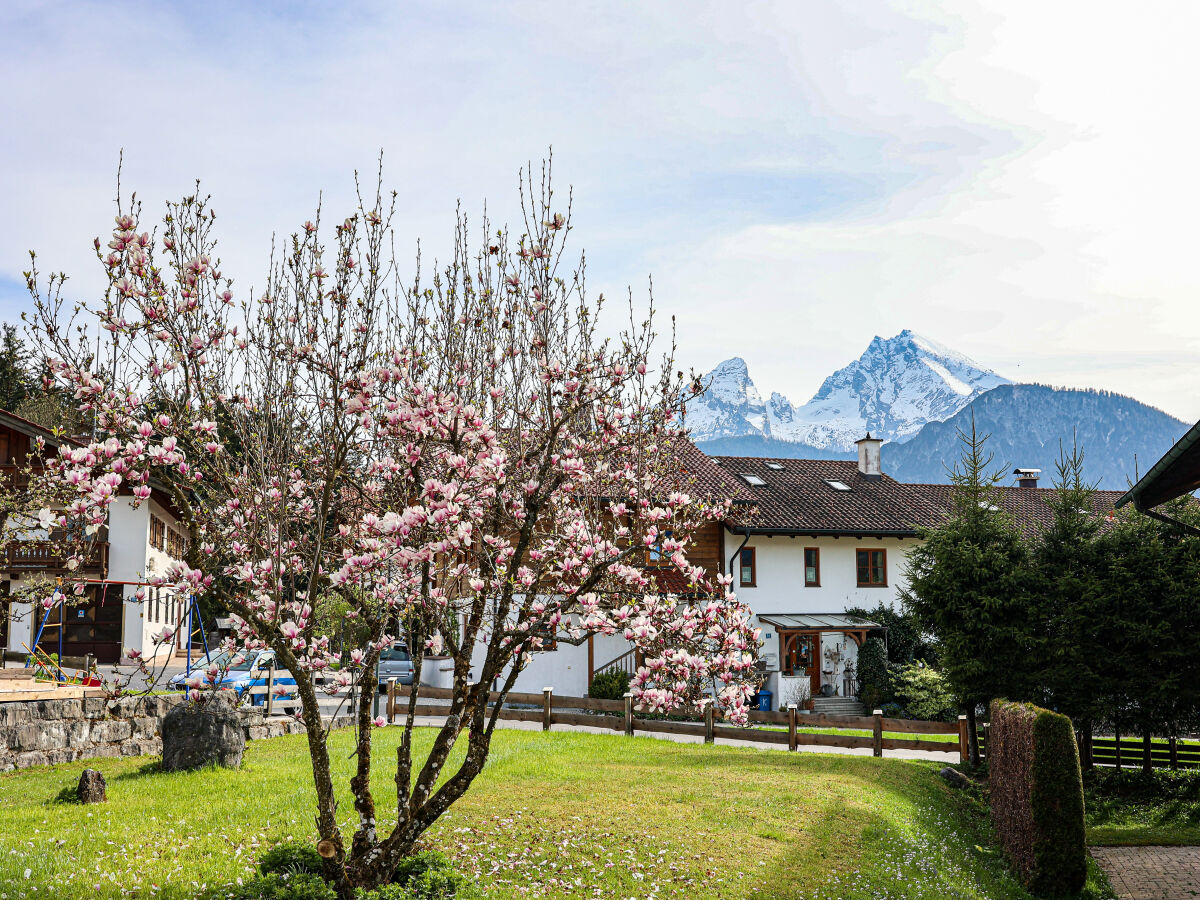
0,695,333,772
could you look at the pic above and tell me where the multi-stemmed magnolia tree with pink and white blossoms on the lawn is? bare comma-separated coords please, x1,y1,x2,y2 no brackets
28,168,757,895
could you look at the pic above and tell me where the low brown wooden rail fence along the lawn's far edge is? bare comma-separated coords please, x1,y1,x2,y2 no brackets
386,678,967,761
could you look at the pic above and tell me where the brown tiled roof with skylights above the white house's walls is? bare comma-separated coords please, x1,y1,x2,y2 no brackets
713,456,946,535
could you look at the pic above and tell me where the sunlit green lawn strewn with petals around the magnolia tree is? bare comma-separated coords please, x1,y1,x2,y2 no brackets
0,728,1110,900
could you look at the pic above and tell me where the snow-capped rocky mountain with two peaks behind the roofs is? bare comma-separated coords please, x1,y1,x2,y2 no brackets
686,330,1009,451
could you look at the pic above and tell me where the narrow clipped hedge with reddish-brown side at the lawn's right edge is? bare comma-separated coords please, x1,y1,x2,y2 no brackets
988,700,1087,896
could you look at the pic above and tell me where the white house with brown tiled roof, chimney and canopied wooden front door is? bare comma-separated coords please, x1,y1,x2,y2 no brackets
715,434,944,707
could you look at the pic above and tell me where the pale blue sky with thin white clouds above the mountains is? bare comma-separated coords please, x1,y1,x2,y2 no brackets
0,0,1200,421
